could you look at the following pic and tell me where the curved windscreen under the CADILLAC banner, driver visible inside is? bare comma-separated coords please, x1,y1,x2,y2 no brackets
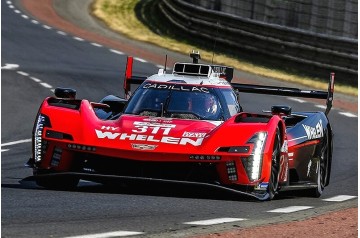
125,82,224,120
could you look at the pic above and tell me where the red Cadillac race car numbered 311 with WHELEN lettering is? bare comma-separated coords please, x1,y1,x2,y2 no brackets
27,52,334,200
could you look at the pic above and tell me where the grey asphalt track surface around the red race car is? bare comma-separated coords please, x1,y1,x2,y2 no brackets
1,1,358,237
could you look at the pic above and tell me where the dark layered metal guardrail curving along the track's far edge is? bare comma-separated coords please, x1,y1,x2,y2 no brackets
159,0,358,86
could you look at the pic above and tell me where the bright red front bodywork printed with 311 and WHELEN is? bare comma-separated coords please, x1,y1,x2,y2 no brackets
38,99,288,191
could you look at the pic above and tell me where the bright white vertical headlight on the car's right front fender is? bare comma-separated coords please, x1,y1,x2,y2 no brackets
241,132,267,181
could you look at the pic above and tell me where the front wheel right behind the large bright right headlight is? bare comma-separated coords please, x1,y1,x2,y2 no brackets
268,128,281,200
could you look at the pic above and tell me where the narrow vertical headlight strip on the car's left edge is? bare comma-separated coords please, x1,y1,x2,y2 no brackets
33,114,50,162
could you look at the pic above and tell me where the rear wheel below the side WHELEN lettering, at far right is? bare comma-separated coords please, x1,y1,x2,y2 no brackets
309,132,330,198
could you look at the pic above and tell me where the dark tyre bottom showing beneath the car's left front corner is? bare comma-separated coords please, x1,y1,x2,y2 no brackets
35,177,80,190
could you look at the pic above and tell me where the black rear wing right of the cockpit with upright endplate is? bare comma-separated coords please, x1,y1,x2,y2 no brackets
231,73,335,115
